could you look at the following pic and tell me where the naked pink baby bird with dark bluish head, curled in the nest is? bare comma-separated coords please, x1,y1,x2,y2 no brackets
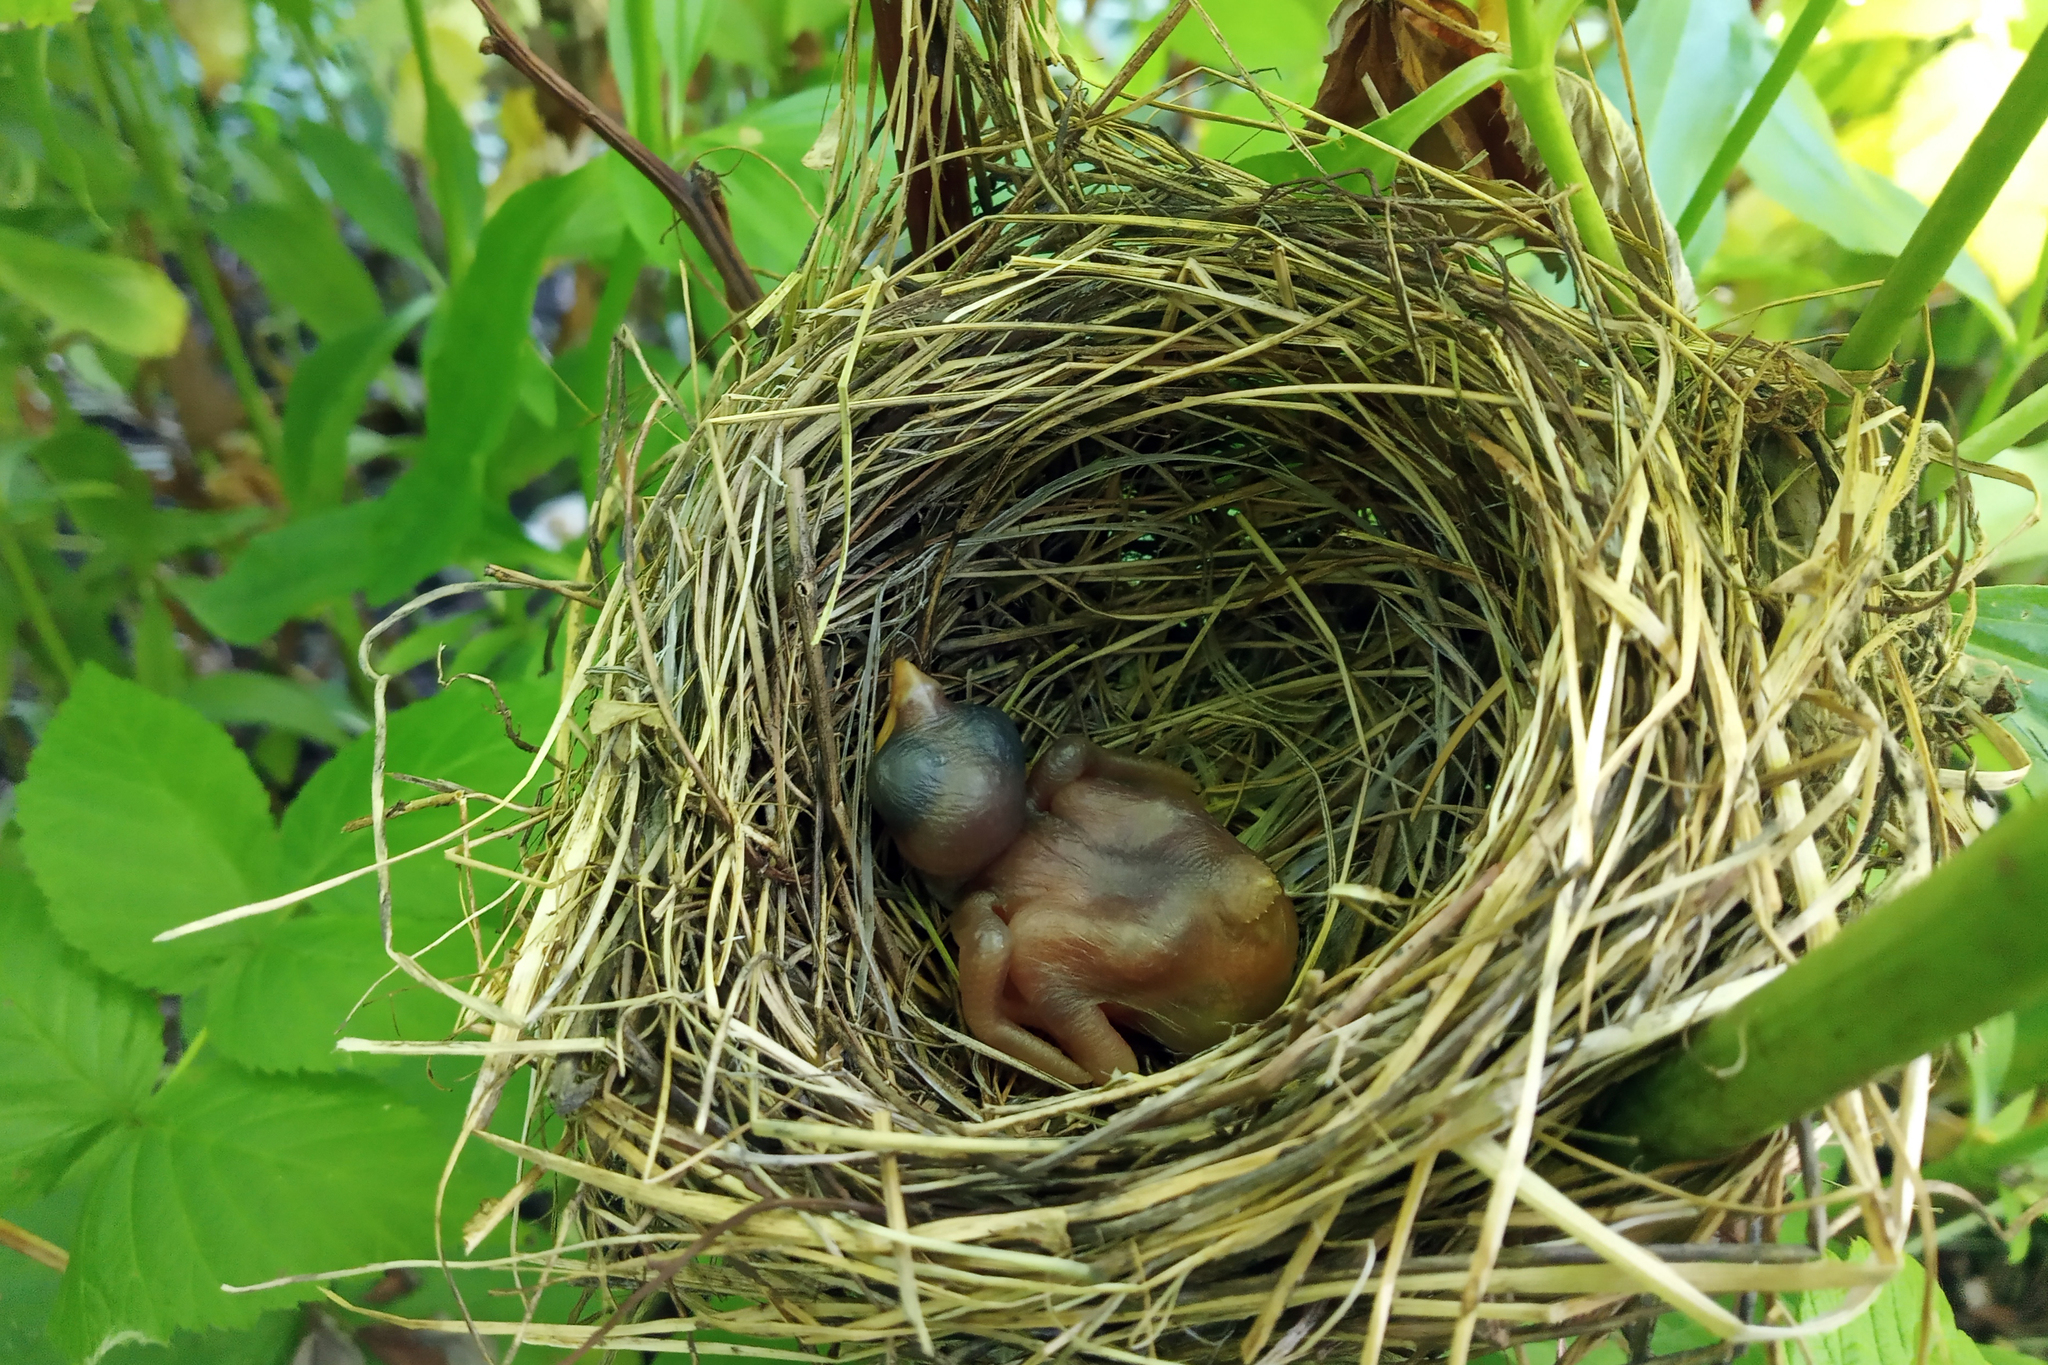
868,659,1296,1085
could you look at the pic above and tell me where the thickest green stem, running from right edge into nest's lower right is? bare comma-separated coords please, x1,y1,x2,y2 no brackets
1589,802,2048,1164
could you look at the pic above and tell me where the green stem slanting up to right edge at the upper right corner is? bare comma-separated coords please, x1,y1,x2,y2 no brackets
1835,39,2048,372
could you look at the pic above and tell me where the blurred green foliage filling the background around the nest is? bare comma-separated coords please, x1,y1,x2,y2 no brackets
0,0,2048,1365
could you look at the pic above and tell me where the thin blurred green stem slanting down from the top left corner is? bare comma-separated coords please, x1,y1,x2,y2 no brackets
88,6,285,469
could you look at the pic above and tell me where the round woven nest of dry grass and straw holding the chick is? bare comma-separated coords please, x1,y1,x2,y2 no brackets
423,6,2007,1365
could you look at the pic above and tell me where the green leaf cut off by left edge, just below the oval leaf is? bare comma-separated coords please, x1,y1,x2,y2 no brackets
0,845,164,1207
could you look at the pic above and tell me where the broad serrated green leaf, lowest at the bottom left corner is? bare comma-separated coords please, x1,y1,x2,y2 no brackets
49,1056,444,1357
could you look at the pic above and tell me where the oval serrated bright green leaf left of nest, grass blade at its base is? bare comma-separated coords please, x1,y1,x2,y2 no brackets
16,665,279,990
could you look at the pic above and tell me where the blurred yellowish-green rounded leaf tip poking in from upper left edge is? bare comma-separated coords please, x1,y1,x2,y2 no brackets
0,227,186,356
